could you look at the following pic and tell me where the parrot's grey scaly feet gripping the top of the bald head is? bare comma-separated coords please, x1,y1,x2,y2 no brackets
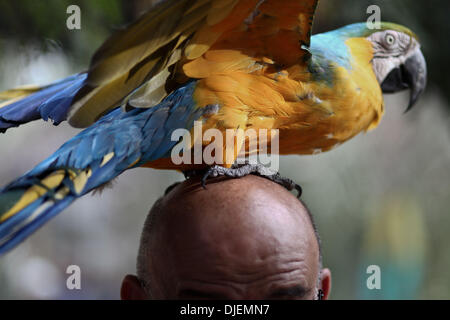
186,163,303,198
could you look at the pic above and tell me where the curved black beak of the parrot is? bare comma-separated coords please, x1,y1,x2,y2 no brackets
381,48,427,112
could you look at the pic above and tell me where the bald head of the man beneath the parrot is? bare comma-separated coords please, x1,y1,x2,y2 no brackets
121,175,331,299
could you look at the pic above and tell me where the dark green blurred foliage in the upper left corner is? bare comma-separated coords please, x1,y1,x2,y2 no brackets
0,0,125,68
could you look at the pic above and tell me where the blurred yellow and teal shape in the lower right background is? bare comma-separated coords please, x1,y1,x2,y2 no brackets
358,193,428,300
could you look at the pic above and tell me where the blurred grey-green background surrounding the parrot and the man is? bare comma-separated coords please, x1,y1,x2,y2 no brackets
0,0,450,299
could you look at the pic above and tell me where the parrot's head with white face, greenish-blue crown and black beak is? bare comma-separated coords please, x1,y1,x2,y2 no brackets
343,22,427,111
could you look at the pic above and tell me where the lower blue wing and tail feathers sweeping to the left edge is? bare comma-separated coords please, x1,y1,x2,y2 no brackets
0,82,203,254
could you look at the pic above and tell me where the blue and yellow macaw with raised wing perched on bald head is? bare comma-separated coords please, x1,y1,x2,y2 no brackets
0,0,427,254
